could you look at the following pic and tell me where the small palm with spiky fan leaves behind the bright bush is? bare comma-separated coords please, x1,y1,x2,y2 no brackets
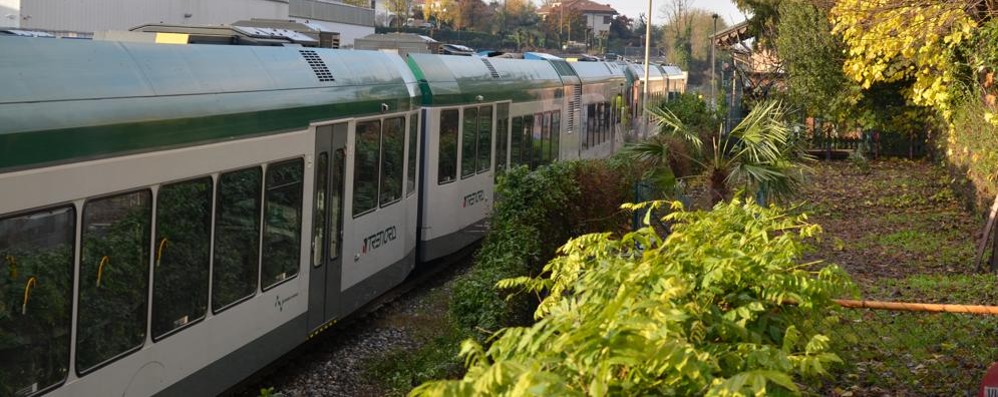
625,102,811,206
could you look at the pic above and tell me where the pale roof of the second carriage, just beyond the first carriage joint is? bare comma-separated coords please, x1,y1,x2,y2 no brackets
408,53,571,105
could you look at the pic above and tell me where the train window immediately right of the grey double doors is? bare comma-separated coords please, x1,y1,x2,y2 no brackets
353,120,381,217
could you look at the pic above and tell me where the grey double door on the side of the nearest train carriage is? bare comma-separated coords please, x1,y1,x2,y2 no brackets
308,123,349,331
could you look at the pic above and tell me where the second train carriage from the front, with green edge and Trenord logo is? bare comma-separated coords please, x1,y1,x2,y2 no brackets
408,54,571,262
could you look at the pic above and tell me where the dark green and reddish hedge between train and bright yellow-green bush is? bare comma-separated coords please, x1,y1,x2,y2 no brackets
451,157,641,337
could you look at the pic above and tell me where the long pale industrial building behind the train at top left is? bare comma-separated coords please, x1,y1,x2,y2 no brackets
0,0,374,48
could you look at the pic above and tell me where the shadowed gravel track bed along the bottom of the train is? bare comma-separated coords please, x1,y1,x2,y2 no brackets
229,243,480,397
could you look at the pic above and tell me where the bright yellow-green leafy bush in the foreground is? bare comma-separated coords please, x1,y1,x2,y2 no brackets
411,199,852,396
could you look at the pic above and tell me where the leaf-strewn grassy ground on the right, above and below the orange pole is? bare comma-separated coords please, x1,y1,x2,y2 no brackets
801,160,998,396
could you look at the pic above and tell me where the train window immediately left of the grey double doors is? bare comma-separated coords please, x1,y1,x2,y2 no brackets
260,159,303,290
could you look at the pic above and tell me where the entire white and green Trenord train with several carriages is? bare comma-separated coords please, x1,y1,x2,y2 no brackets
0,37,675,397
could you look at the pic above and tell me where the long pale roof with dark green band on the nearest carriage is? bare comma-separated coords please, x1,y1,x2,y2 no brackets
0,37,417,169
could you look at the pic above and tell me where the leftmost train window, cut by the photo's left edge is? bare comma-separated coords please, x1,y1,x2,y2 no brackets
0,206,76,396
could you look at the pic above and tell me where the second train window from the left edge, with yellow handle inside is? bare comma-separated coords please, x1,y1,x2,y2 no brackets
76,190,152,374
